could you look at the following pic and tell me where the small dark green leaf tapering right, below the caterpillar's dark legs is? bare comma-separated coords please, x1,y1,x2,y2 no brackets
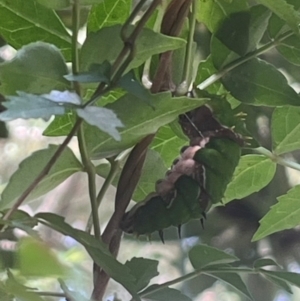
189,245,239,270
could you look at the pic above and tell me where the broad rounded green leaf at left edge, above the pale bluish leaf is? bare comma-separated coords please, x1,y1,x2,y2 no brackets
0,41,70,94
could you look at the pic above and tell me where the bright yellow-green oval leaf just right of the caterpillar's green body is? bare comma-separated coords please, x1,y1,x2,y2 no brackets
223,155,276,203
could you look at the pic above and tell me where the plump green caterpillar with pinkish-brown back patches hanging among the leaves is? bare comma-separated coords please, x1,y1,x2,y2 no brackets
120,107,243,242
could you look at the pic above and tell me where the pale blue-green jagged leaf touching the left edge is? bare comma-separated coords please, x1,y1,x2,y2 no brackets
0,92,65,121
